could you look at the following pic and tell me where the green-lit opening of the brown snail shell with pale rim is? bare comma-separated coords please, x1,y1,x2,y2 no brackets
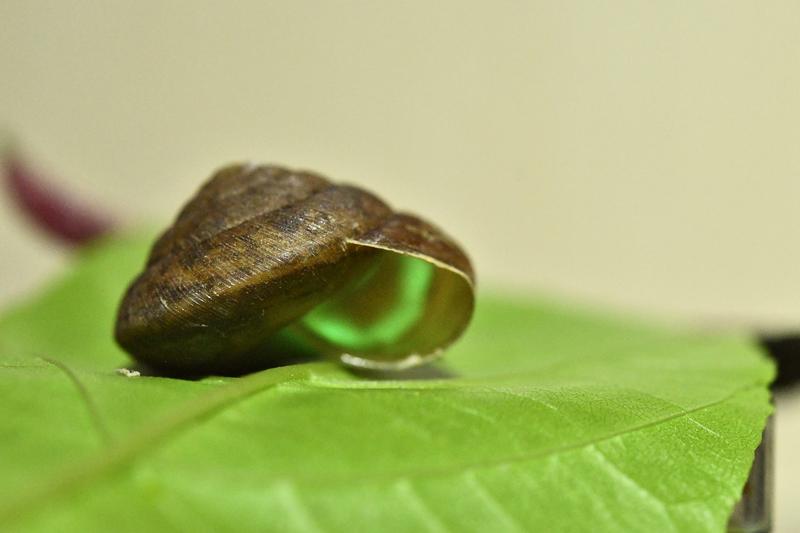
296,245,473,369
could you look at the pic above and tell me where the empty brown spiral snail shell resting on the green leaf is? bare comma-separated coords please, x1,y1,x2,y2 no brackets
115,164,475,375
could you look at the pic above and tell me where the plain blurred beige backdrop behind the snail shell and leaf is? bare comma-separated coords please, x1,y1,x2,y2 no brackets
0,0,800,531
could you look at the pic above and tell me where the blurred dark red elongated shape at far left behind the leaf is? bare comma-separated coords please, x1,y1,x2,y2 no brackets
3,150,115,246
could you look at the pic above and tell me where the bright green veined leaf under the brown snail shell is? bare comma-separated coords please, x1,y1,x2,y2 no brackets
0,234,772,532
